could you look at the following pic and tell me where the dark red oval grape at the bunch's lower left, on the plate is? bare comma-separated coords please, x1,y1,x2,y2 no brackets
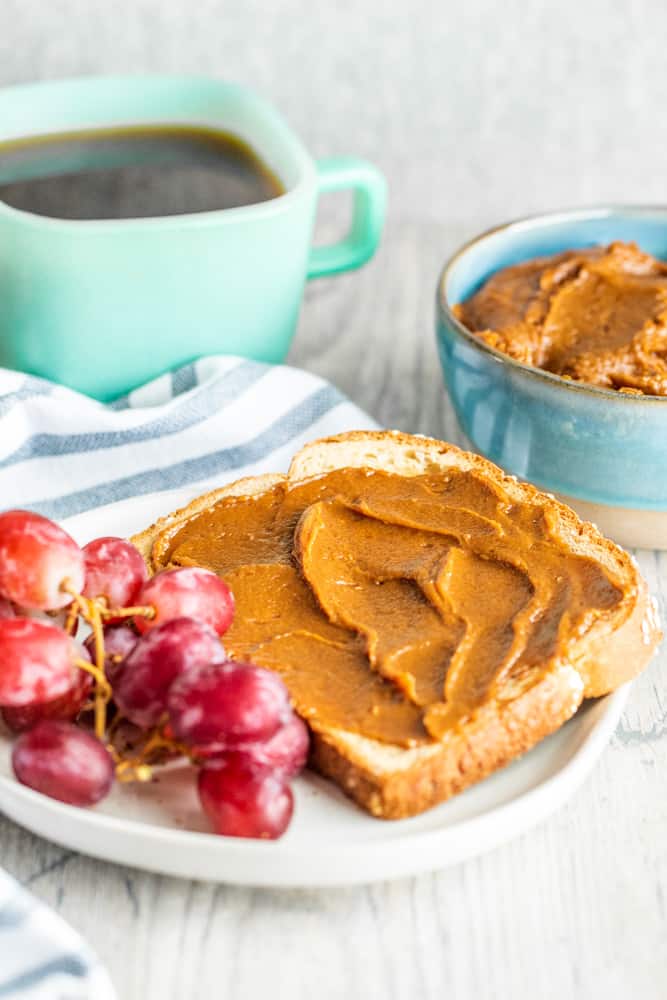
12,719,114,806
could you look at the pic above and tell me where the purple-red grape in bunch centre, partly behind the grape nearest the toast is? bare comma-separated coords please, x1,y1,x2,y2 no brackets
114,618,224,728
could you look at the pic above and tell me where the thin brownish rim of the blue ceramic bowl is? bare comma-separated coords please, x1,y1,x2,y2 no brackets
436,203,667,406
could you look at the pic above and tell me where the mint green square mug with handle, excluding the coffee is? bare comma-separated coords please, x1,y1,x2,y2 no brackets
0,77,386,400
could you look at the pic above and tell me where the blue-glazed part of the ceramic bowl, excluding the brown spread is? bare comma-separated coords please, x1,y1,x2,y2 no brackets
437,207,667,521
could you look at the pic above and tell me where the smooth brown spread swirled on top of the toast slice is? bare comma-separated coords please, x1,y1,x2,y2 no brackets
153,469,624,746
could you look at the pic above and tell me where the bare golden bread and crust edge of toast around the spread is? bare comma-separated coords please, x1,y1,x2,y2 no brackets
132,431,661,819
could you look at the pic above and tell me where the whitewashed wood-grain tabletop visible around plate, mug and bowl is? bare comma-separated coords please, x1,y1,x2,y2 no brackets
0,223,667,1000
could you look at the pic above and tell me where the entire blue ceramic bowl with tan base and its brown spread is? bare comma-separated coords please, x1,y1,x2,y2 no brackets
437,208,667,548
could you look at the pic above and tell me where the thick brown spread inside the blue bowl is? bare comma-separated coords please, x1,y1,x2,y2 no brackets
454,243,667,396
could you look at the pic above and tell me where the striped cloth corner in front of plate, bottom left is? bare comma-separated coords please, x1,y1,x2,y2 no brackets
0,870,116,1000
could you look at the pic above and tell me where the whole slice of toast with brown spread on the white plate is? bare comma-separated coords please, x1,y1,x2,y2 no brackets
133,431,660,819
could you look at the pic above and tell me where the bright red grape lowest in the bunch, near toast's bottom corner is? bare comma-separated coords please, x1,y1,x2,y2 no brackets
197,753,294,840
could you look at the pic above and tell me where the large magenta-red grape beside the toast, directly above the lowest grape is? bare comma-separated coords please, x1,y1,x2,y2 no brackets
167,661,291,748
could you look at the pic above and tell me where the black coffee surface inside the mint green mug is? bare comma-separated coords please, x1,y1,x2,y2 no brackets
0,125,284,219
